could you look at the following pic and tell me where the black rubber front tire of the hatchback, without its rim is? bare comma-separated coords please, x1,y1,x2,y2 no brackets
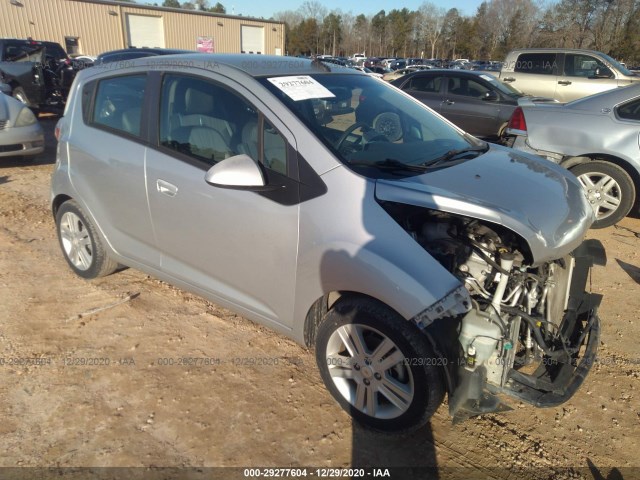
316,302,444,432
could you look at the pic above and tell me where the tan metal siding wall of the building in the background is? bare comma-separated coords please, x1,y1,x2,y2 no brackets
0,0,284,55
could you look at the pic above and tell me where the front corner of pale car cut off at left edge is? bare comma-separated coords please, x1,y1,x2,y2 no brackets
0,83,44,158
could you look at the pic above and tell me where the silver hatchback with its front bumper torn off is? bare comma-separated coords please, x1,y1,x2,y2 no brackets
51,54,604,431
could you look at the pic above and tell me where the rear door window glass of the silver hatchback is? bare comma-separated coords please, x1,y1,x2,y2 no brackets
90,74,147,137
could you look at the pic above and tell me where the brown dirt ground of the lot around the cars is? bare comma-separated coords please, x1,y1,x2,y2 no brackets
0,117,640,479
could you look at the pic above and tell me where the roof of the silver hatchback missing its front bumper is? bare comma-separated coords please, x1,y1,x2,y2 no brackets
100,52,364,77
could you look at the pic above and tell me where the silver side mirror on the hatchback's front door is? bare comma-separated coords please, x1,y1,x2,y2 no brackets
204,154,266,190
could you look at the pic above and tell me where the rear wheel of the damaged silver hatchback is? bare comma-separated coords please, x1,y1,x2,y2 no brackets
56,200,118,279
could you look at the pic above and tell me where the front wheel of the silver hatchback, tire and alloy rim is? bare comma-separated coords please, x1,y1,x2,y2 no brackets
316,298,445,432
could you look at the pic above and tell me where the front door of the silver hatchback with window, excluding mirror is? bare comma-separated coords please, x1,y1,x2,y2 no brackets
146,74,298,327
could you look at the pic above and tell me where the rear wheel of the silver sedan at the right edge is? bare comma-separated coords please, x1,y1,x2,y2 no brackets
570,160,636,229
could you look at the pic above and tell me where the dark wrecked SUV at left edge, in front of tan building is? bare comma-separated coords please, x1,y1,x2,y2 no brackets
0,38,76,110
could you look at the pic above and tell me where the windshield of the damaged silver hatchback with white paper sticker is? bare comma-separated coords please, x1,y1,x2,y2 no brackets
260,74,485,176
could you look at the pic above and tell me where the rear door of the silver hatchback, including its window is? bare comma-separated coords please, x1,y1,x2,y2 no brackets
68,73,160,268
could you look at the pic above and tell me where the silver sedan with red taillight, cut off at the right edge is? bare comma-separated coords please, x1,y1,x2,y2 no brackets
506,85,640,228
